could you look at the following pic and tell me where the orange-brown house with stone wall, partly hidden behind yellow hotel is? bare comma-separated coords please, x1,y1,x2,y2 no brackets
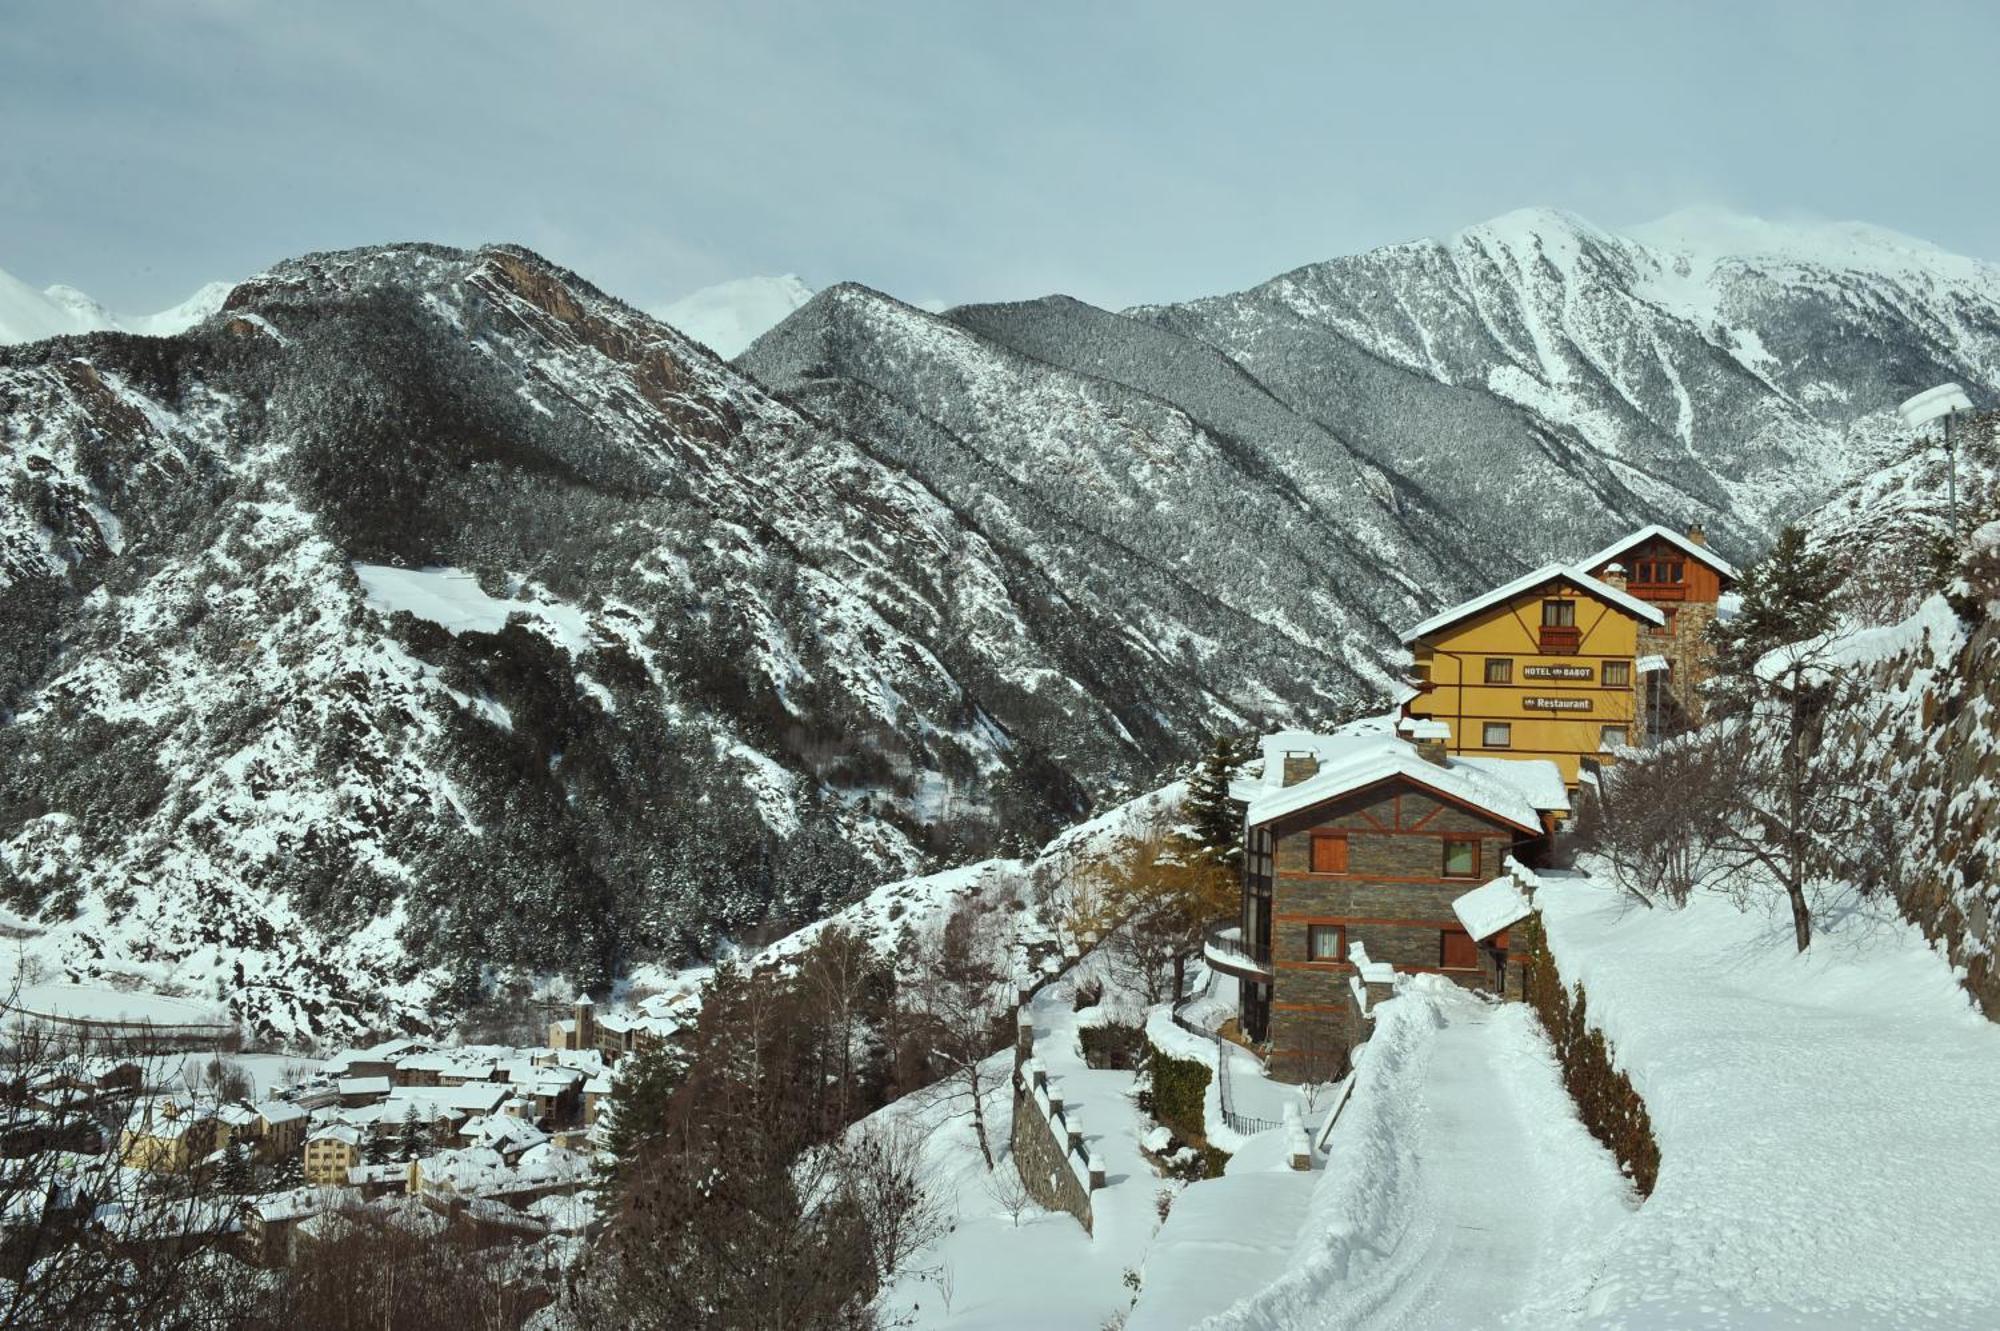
1576,526,1736,735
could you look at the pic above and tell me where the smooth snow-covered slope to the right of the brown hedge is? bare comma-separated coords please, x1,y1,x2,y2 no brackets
1538,879,2000,1327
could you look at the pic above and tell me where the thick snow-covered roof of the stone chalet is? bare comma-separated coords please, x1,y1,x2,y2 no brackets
1246,727,1570,831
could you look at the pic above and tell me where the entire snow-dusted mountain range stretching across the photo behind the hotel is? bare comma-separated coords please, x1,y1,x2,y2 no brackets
0,212,2000,1033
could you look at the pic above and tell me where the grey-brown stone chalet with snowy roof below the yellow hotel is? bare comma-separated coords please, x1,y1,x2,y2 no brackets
1206,717,1570,1081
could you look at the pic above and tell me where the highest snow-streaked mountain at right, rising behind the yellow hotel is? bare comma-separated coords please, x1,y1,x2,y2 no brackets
1130,210,2000,556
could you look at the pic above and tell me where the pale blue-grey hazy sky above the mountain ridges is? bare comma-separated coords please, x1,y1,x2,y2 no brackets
0,0,2000,312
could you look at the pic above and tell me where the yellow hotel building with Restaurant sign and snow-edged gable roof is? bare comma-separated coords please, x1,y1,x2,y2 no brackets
1402,564,1666,787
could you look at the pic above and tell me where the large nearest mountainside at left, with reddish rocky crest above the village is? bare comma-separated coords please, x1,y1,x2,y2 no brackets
0,246,1224,1035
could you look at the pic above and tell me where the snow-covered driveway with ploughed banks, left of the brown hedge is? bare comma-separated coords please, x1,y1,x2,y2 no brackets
1168,975,1630,1331
